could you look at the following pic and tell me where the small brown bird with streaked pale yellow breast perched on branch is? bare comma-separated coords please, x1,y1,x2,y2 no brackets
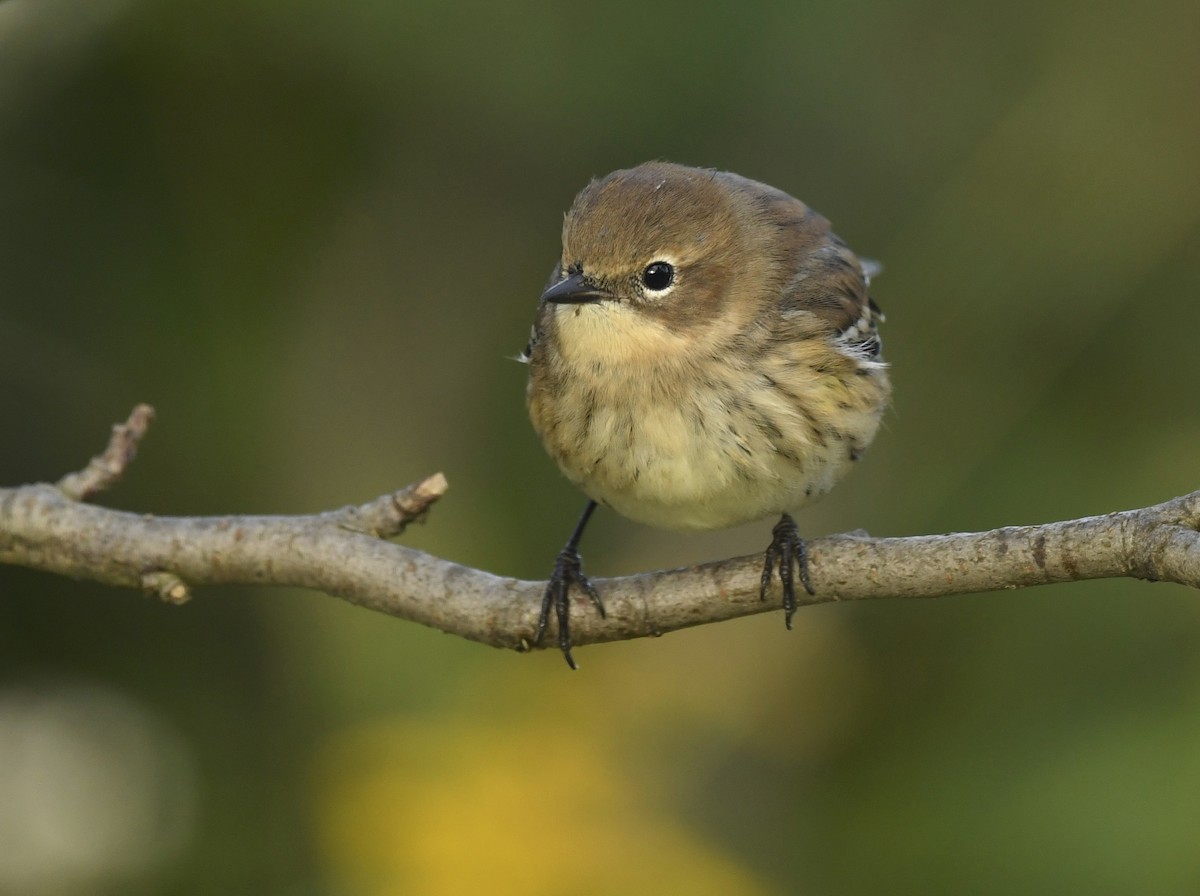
522,162,890,668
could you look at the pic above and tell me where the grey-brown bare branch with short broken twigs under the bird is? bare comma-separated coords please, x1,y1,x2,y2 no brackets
0,404,1200,650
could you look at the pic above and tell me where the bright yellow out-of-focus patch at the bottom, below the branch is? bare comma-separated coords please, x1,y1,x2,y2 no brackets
314,720,773,896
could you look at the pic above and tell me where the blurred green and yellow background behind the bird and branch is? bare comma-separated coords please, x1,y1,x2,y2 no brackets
0,0,1200,896
